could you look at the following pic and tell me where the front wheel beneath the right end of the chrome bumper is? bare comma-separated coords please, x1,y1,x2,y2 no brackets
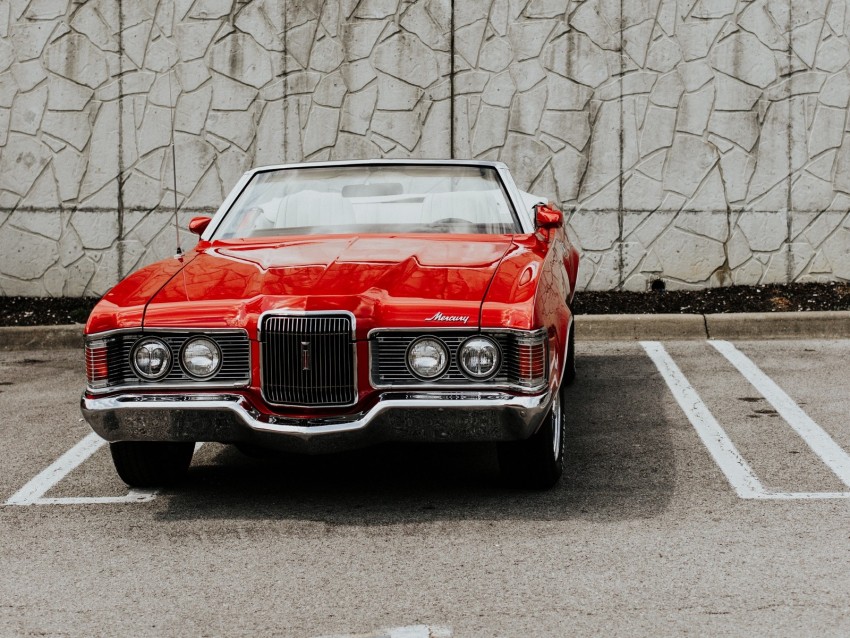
499,392,564,490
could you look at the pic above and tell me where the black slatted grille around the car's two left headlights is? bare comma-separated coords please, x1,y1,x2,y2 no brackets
89,330,251,387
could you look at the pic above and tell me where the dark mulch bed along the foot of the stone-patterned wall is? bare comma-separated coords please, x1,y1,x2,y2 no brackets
0,282,850,326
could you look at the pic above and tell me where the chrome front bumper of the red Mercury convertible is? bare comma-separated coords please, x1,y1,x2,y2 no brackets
81,391,551,452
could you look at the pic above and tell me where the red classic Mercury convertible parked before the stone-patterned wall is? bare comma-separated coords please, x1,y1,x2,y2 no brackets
82,160,578,488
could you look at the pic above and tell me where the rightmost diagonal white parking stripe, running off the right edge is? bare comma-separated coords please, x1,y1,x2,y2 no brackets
709,341,850,487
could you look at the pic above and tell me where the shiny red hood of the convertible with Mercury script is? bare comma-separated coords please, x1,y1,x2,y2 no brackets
144,235,513,334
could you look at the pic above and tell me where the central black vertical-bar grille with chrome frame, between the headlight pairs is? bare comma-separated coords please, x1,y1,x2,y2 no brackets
261,315,357,407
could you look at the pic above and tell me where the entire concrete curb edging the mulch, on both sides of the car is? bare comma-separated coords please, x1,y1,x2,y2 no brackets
0,311,850,351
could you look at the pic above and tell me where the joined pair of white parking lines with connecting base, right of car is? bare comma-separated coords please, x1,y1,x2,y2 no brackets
641,341,850,500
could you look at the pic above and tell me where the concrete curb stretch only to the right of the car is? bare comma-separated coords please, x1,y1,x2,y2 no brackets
576,311,850,341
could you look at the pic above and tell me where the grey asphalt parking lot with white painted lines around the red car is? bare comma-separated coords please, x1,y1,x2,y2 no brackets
0,340,850,638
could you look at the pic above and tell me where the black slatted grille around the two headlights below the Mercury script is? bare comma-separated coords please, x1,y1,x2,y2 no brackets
371,331,510,386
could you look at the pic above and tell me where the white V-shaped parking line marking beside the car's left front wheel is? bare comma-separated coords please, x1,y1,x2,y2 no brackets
5,432,156,505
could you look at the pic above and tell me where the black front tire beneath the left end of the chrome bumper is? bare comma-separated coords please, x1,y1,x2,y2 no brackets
109,441,195,487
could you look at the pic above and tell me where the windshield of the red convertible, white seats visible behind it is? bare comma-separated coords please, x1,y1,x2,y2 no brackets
212,165,521,239
